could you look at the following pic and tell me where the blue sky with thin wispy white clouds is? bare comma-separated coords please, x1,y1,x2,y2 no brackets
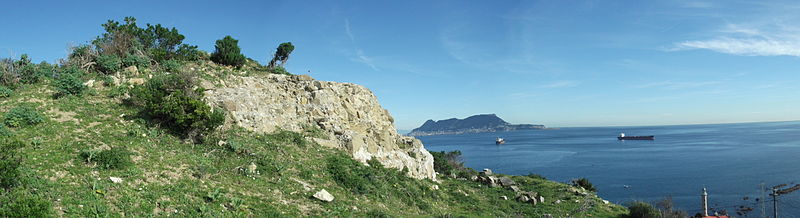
0,1,800,129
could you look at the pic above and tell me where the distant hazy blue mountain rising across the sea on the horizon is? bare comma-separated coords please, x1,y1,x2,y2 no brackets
408,114,545,136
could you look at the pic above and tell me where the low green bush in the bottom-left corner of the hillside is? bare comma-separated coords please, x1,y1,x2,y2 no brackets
0,190,55,217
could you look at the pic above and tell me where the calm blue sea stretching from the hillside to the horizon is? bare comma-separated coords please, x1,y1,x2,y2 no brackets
417,121,800,217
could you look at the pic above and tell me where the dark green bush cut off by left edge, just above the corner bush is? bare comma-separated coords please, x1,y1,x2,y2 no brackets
0,139,25,190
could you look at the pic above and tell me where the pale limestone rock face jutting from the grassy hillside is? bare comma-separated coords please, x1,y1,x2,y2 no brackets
202,74,436,179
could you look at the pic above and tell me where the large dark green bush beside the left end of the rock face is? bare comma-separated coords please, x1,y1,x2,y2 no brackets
130,74,225,138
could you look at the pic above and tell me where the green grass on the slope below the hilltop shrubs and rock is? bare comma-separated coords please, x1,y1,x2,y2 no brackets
0,70,627,217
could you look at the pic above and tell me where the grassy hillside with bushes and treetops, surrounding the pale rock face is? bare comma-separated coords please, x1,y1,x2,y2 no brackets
0,17,627,217
